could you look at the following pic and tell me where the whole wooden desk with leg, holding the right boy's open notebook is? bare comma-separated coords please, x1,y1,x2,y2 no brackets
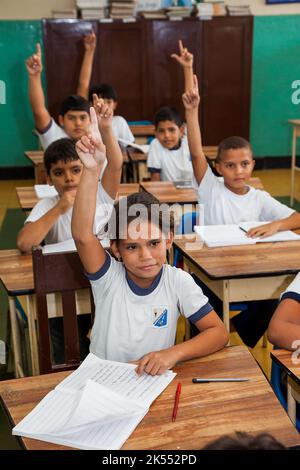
174,235,300,331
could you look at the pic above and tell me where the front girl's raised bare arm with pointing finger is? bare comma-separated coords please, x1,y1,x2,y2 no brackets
72,108,105,273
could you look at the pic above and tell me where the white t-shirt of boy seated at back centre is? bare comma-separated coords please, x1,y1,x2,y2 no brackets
147,136,193,181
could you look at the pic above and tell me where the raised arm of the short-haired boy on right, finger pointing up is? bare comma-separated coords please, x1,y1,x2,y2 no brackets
182,75,207,184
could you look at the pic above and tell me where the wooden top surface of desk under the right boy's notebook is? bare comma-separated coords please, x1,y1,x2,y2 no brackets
174,236,300,279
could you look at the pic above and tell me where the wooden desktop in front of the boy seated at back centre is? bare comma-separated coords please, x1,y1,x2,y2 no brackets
140,181,198,204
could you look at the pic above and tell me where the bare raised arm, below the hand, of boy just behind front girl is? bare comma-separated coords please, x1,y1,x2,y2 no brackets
101,126,123,199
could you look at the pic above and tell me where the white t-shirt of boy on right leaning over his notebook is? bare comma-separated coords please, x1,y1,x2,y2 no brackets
198,166,295,225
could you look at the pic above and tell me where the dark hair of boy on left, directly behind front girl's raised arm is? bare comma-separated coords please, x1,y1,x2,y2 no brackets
44,137,79,175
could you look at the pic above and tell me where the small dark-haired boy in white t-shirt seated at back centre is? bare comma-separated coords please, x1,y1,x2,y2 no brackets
147,107,193,181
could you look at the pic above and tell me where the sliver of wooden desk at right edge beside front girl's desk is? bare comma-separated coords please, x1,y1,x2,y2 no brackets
271,349,300,424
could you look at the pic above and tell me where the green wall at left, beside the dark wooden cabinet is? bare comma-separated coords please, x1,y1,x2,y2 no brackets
0,21,41,167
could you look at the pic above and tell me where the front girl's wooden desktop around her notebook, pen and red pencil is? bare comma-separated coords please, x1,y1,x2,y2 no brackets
0,346,300,450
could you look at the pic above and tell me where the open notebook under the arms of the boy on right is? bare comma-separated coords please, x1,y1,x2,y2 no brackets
194,222,300,247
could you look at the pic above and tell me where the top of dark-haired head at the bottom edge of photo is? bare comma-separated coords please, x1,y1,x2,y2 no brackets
201,432,286,450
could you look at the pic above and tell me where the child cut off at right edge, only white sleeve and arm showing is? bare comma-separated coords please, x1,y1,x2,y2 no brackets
268,273,300,351
